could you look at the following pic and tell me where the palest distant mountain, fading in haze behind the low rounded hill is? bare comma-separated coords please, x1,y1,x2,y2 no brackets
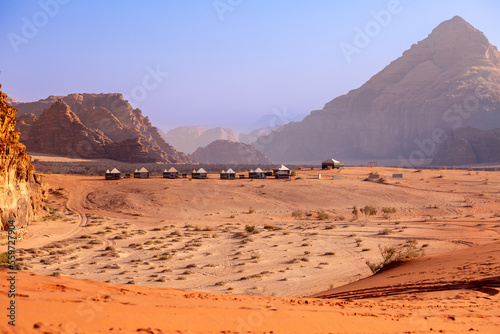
165,126,238,154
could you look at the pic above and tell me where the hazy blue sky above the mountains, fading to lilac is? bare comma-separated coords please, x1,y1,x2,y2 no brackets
0,0,500,130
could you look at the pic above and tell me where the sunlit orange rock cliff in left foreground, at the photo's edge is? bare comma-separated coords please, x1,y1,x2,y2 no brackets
0,86,47,230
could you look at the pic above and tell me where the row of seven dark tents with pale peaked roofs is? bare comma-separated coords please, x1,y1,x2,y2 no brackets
105,165,291,180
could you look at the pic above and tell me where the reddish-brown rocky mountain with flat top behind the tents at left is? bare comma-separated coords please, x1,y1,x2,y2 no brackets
15,94,191,163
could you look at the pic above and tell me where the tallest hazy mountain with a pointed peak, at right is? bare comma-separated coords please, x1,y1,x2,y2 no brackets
253,16,500,164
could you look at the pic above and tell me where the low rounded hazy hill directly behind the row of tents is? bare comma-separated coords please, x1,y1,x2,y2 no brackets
191,140,272,165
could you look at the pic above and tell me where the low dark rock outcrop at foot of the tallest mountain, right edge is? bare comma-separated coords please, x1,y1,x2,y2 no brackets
432,127,500,166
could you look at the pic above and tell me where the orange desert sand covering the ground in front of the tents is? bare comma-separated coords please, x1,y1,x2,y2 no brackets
1,167,500,333
